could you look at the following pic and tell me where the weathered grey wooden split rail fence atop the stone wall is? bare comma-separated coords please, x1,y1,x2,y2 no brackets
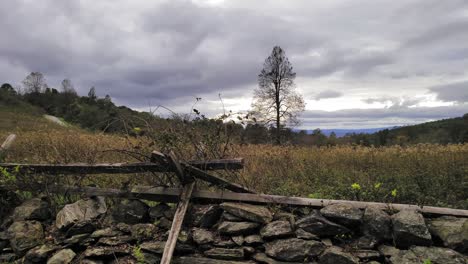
0,135,468,264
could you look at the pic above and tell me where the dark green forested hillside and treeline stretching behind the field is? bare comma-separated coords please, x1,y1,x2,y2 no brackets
0,83,468,146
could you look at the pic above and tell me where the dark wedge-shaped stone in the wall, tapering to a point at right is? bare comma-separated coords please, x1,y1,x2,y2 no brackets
296,210,351,237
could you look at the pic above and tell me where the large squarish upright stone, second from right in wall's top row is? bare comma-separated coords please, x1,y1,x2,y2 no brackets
392,210,432,248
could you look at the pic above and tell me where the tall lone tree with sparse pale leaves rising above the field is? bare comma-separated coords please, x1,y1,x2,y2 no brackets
252,46,305,144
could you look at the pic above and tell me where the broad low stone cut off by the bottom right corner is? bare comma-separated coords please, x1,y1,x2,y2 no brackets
389,246,468,264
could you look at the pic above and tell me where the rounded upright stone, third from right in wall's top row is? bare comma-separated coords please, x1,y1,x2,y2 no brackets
361,206,392,242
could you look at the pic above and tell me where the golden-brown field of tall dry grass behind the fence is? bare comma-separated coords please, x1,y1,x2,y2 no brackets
0,108,468,209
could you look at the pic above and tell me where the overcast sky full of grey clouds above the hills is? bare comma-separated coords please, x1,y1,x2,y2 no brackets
0,0,468,129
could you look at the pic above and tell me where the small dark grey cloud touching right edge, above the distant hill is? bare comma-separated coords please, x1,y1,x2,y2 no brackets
429,81,468,103
